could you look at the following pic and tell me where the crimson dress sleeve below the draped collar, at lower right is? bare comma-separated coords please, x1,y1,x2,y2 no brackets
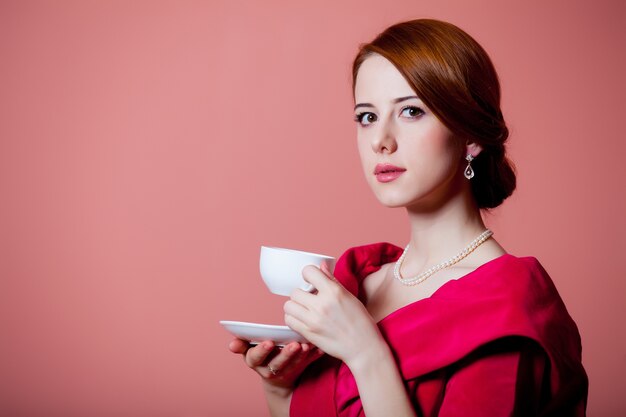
438,337,549,417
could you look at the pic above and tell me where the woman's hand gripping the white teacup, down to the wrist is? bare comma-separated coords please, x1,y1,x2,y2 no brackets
284,265,387,367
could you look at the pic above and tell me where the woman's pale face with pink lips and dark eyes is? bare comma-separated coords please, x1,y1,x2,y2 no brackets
354,54,464,210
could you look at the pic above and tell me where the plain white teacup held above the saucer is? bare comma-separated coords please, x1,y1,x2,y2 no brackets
259,246,335,295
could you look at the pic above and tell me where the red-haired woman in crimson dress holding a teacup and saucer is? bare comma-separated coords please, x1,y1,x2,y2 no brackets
230,19,587,417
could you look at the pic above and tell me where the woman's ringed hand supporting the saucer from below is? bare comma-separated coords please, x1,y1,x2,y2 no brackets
228,339,324,390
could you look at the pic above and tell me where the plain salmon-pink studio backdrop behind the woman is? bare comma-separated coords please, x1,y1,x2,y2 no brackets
0,0,626,417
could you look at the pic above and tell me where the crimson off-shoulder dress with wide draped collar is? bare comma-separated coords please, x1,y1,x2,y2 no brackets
290,243,588,417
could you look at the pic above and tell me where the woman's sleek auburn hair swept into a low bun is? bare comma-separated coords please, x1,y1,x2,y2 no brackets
352,19,515,209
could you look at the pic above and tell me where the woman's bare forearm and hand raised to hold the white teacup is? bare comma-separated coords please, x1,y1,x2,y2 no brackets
284,266,415,417
